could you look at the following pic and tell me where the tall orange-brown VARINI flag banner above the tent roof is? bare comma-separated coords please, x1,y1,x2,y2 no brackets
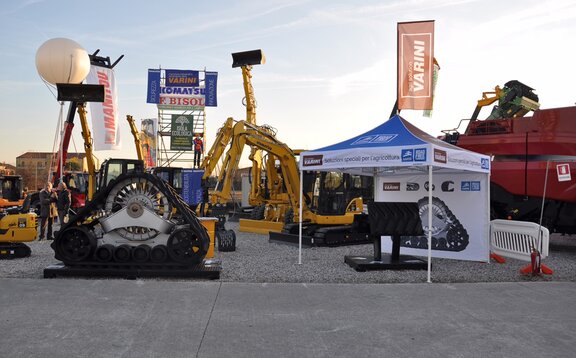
397,21,434,110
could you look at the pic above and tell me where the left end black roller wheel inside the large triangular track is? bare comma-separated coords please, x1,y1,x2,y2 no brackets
52,226,96,262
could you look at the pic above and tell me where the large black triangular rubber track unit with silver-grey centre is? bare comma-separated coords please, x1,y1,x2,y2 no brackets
45,172,219,278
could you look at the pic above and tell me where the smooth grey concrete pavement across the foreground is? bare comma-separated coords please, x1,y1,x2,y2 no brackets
0,279,576,357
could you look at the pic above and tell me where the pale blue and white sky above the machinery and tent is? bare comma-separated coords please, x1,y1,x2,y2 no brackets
0,0,576,164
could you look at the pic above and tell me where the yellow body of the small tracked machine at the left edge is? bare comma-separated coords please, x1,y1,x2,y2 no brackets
0,213,38,243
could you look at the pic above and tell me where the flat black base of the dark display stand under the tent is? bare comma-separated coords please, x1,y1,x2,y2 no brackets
344,255,428,272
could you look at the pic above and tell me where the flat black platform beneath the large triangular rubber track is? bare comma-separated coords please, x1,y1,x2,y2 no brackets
44,259,222,280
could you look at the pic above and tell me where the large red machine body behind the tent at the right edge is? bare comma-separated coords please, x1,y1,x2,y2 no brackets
452,107,576,233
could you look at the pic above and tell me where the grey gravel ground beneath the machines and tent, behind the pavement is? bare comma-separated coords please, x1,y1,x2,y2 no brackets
0,222,576,283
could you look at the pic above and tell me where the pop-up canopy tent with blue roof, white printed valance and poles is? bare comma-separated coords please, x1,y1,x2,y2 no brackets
298,115,490,282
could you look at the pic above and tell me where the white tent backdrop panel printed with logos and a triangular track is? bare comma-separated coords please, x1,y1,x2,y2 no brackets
375,173,490,261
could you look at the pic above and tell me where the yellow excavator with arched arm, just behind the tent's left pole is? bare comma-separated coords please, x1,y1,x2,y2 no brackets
212,121,373,245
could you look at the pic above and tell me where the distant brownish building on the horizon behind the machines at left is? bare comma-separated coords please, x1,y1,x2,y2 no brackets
16,152,87,190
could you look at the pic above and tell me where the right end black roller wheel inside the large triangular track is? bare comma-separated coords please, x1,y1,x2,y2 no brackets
167,228,210,265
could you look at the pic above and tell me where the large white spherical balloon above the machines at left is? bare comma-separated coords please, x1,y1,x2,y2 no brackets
36,38,90,84
